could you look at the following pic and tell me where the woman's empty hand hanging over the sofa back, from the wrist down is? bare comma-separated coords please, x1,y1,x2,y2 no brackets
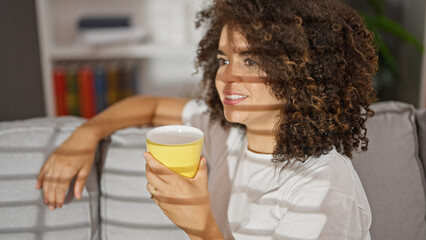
36,127,98,210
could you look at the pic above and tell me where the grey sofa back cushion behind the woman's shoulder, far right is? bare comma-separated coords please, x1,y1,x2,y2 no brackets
353,102,426,240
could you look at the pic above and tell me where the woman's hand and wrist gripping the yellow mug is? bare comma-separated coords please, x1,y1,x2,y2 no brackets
144,152,224,239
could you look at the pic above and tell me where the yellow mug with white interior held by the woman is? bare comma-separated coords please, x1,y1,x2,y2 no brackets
146,125,204,178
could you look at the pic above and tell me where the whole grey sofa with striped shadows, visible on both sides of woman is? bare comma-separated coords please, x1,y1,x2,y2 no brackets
0,102,426,240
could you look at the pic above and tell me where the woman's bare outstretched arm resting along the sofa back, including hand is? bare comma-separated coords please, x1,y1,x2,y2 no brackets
36,96,188,210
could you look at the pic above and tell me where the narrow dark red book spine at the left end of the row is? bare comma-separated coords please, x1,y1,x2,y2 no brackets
53,68,69,116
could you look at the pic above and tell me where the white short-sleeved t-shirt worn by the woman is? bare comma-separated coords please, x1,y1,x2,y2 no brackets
182,100,371,240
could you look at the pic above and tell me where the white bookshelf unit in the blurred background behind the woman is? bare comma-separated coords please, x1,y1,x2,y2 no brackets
36,0,205,116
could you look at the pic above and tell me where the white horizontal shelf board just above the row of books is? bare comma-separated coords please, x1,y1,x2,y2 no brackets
49,44,195,61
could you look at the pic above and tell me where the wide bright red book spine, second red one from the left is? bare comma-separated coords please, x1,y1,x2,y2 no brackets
78,67,96,118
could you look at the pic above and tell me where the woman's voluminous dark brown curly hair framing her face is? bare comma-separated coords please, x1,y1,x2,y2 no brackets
196,0,378,163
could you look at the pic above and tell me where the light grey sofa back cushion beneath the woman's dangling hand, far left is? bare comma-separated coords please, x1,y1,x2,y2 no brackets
0,117,99,240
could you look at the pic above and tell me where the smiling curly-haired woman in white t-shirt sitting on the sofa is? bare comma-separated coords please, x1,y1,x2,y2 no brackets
36,0,377,239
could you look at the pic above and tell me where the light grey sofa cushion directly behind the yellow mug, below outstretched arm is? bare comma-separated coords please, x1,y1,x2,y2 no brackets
100,128,188,240
